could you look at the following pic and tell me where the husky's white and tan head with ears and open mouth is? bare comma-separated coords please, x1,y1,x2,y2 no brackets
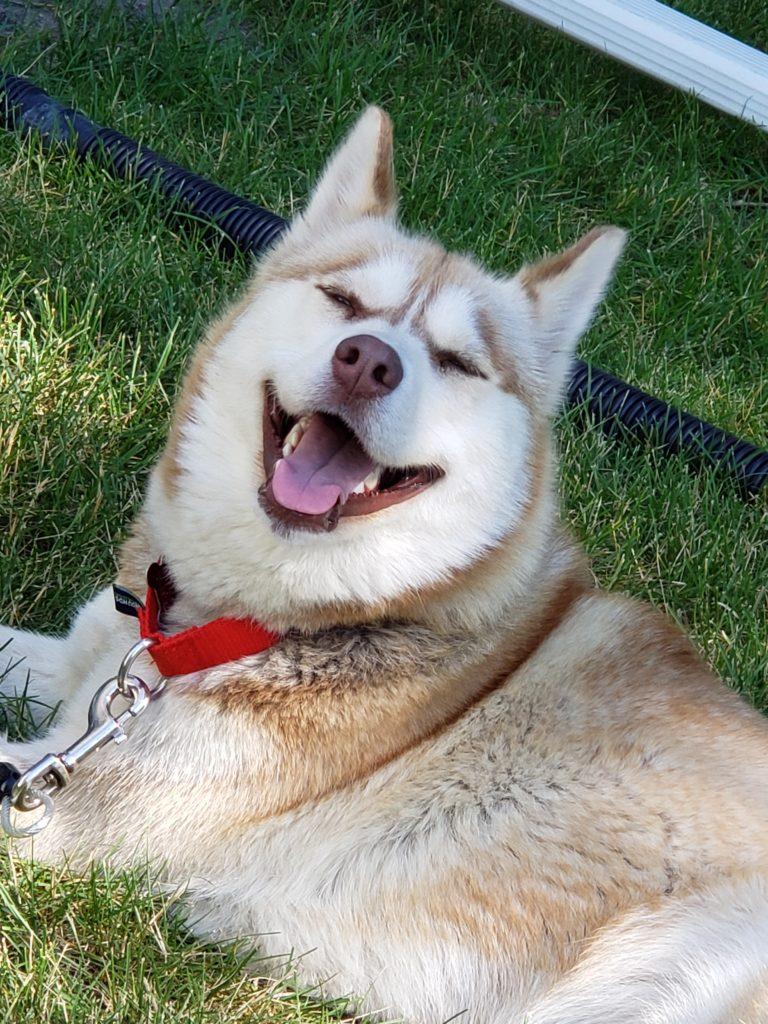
150,108,624,626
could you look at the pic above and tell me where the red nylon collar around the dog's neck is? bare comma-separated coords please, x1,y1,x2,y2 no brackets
116,562,281,676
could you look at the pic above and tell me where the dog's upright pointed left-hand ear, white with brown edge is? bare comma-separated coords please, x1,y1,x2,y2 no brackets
302,106,397,232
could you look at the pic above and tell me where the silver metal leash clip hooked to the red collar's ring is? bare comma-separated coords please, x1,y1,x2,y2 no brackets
0,639,166,839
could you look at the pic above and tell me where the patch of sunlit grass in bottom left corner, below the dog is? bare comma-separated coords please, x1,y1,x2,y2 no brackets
0,861,360,1024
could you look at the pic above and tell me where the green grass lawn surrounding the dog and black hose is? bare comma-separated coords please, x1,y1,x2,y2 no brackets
0,0,768,1024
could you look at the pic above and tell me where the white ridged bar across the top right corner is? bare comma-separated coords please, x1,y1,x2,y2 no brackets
502,0,768,130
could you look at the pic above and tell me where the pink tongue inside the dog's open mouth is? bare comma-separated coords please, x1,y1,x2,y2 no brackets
272,413,375,515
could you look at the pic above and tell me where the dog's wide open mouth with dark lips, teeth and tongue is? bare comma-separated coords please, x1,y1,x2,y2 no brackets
259,385,443,530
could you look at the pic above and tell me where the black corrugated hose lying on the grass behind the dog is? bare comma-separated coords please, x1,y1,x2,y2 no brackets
0,72,768,497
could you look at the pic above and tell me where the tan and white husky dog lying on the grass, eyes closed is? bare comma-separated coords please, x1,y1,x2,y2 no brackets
0,108,768,1024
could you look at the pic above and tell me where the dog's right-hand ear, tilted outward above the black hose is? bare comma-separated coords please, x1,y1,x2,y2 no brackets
514,226,627,413
